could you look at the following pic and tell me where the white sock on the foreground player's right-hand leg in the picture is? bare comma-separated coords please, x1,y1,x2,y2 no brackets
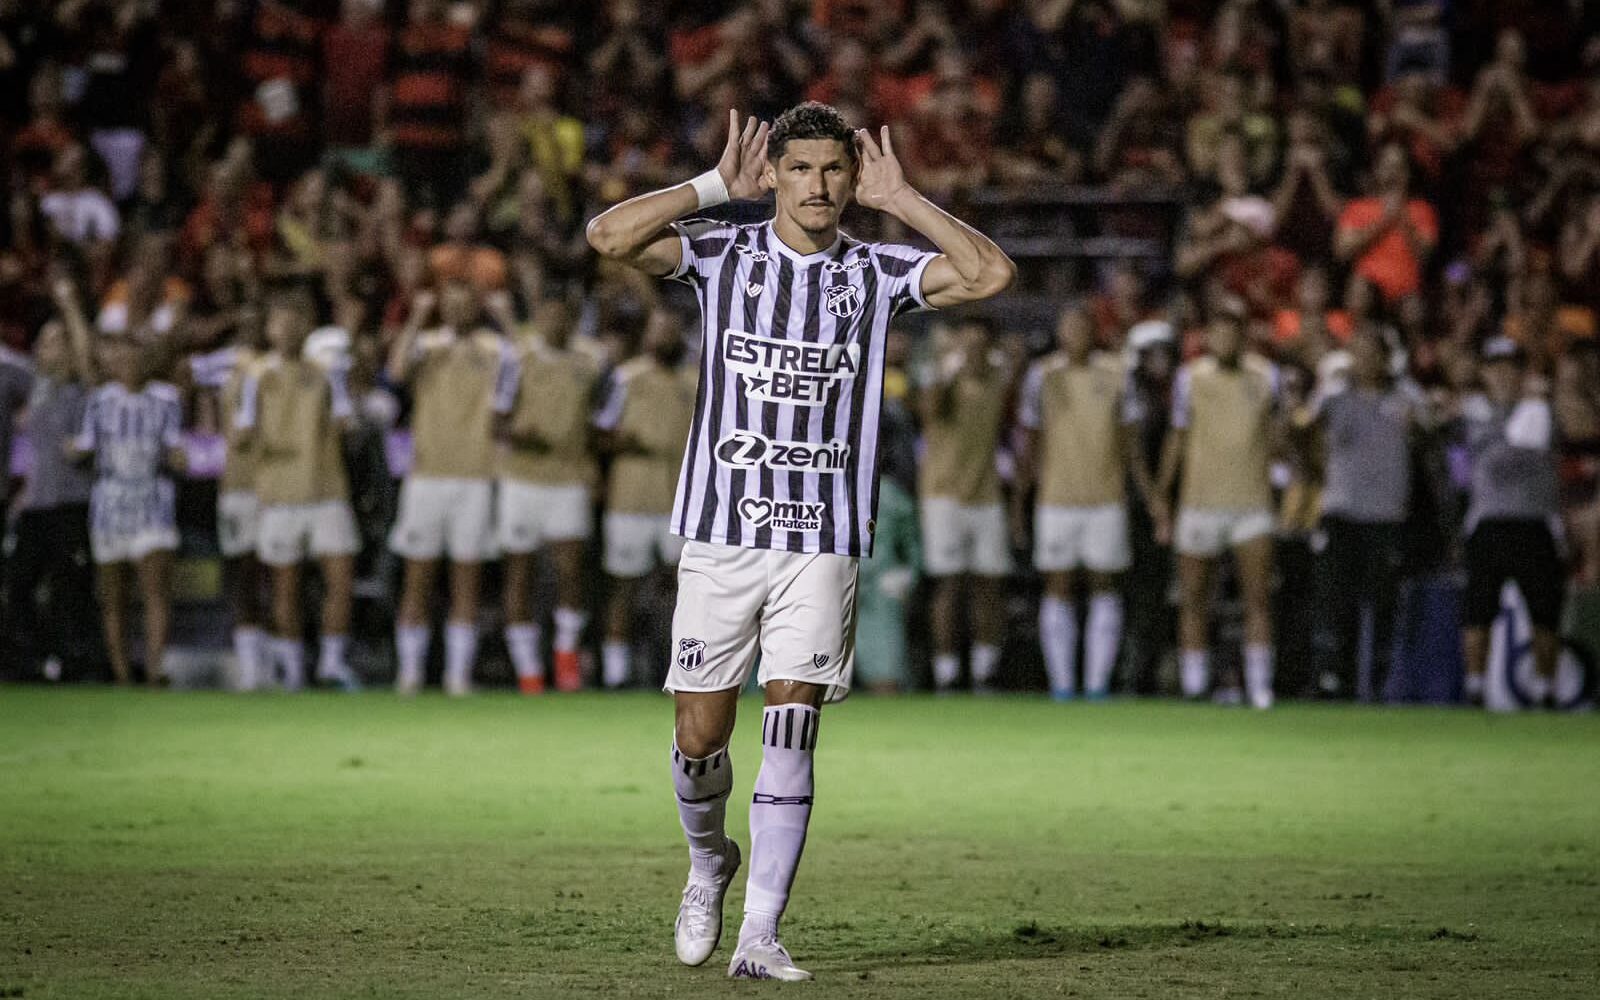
739,706,821,942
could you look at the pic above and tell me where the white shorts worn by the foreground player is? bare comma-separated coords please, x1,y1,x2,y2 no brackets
666,542,856,701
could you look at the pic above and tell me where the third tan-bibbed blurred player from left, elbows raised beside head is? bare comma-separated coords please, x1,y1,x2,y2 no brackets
389,278,515,694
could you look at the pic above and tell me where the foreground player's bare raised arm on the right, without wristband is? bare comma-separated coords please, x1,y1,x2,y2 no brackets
856,125,1016,309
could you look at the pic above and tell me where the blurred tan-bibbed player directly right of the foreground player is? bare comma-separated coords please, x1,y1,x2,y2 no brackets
917,317,1013,691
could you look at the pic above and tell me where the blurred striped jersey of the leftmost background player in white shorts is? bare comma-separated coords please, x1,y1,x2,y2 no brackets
74,382,182,482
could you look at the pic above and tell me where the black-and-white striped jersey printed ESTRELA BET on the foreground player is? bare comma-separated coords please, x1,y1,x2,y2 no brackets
669,219,938,557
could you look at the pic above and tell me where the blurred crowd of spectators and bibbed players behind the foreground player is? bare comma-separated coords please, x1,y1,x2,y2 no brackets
0,0,1600,704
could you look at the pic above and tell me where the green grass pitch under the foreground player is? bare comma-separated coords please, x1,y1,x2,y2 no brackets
0,688,1600,1000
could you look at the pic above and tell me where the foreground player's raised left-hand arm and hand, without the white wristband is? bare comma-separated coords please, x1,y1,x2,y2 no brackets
586,109,766,277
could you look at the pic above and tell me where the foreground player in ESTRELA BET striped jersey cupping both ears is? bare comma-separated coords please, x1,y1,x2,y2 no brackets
589,102,1016,979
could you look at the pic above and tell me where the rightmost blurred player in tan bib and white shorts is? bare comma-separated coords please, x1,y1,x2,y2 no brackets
1157,315,1278,709
